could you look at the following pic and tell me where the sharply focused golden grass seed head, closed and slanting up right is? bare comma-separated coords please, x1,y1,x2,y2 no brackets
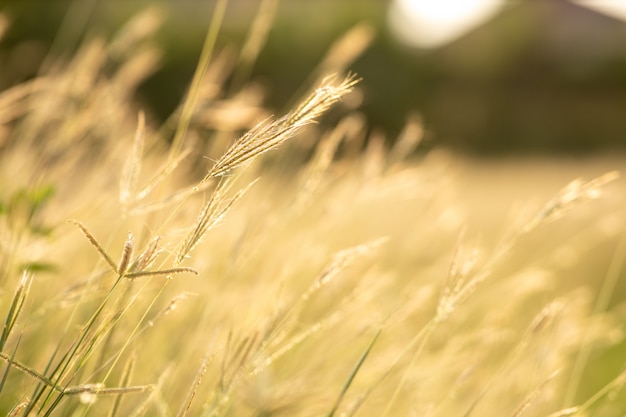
202,76,358,182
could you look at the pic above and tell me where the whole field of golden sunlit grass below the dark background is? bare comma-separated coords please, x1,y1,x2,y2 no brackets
0,4,626,416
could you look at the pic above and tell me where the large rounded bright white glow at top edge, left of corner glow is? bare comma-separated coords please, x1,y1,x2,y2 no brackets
389,0,503,48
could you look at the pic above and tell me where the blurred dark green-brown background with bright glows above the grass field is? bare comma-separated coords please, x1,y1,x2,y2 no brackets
0,0,626,156
